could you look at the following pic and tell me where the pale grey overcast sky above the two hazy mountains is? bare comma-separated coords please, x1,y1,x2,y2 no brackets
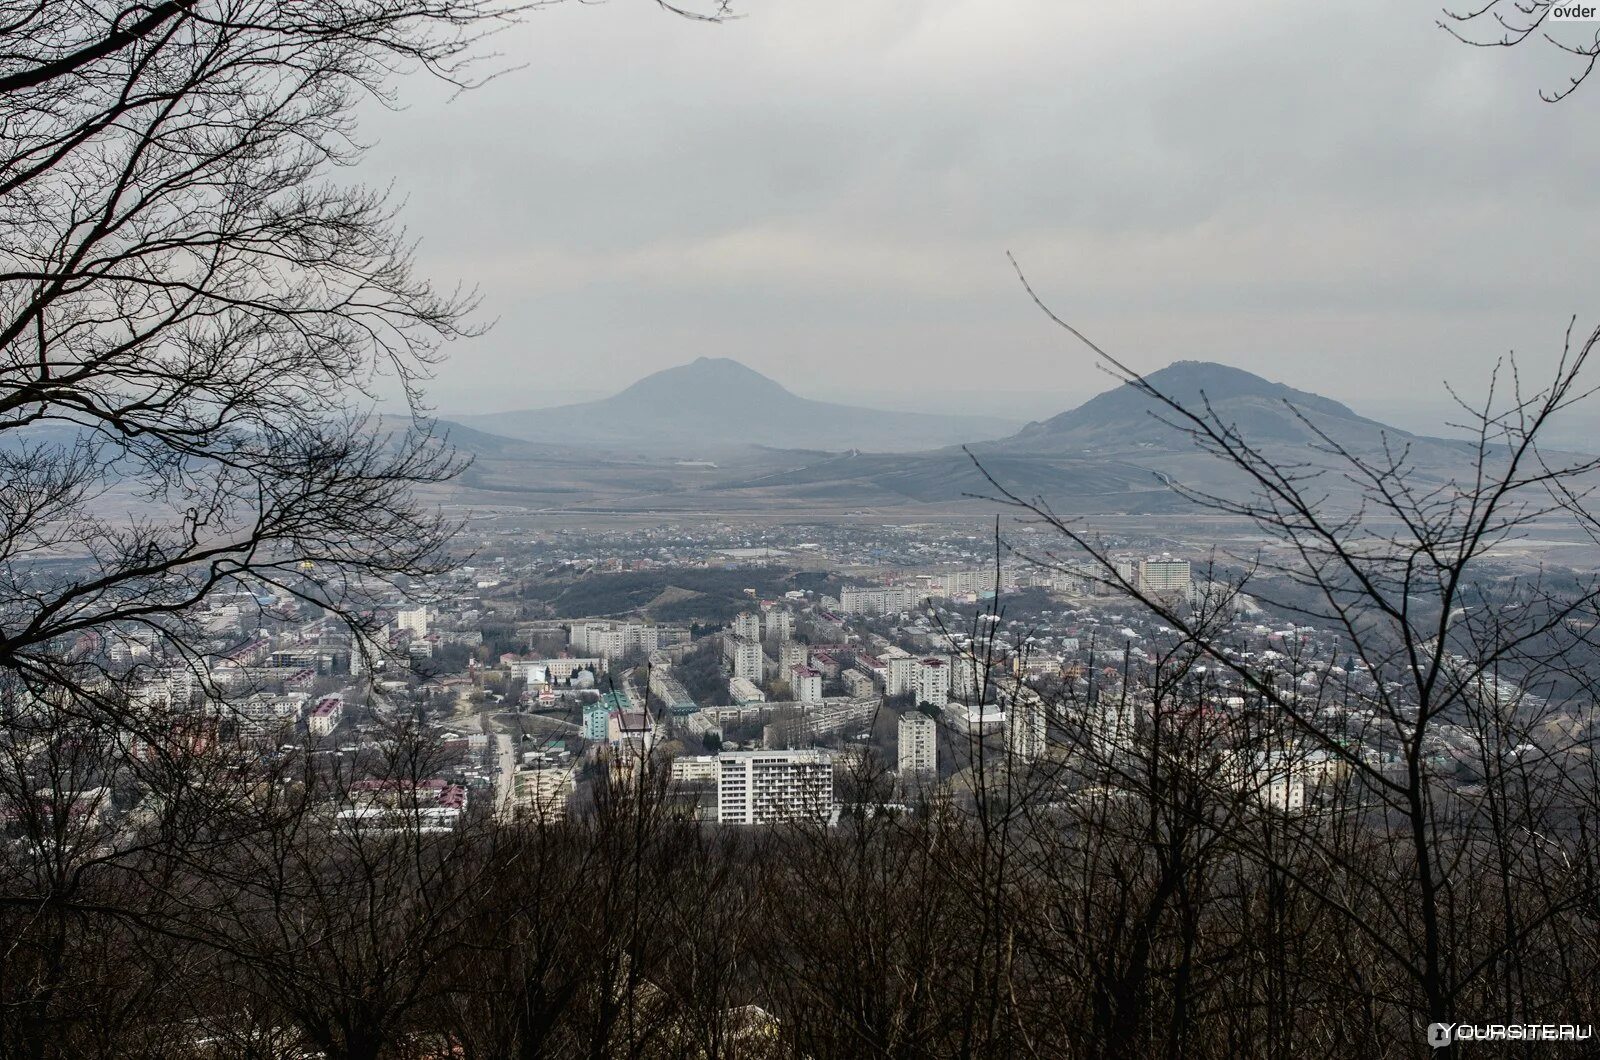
360,0,1600,432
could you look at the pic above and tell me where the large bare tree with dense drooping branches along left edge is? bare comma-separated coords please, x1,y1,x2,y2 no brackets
0,0,722,1055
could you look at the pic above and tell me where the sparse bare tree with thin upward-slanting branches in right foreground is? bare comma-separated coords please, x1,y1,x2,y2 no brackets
972,264,1600,1056
